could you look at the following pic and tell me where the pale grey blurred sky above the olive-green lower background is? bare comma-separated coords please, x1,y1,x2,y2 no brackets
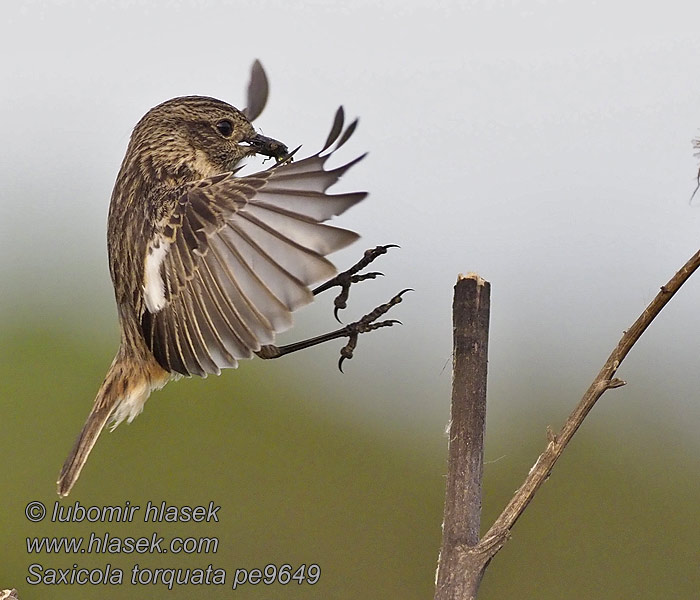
0,0,700,443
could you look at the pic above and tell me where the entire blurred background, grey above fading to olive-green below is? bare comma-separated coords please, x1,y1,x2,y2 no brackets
0,0,700,600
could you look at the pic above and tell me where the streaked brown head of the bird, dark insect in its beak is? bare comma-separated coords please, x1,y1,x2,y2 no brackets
123,96,287,183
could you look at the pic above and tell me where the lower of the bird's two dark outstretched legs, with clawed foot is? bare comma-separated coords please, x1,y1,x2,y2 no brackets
256,289,411,372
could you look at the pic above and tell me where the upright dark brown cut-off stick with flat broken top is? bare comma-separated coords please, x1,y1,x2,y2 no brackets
435,274,491,600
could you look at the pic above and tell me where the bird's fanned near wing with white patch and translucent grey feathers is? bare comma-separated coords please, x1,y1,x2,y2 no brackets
141,109,367,376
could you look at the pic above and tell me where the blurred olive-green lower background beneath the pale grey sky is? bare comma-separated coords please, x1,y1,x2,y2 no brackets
0,302,700,599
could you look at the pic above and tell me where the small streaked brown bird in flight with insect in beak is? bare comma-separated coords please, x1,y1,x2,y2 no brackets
58,65,403,496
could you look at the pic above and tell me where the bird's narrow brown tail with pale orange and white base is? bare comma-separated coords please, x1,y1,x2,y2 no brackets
57,354,167,497
